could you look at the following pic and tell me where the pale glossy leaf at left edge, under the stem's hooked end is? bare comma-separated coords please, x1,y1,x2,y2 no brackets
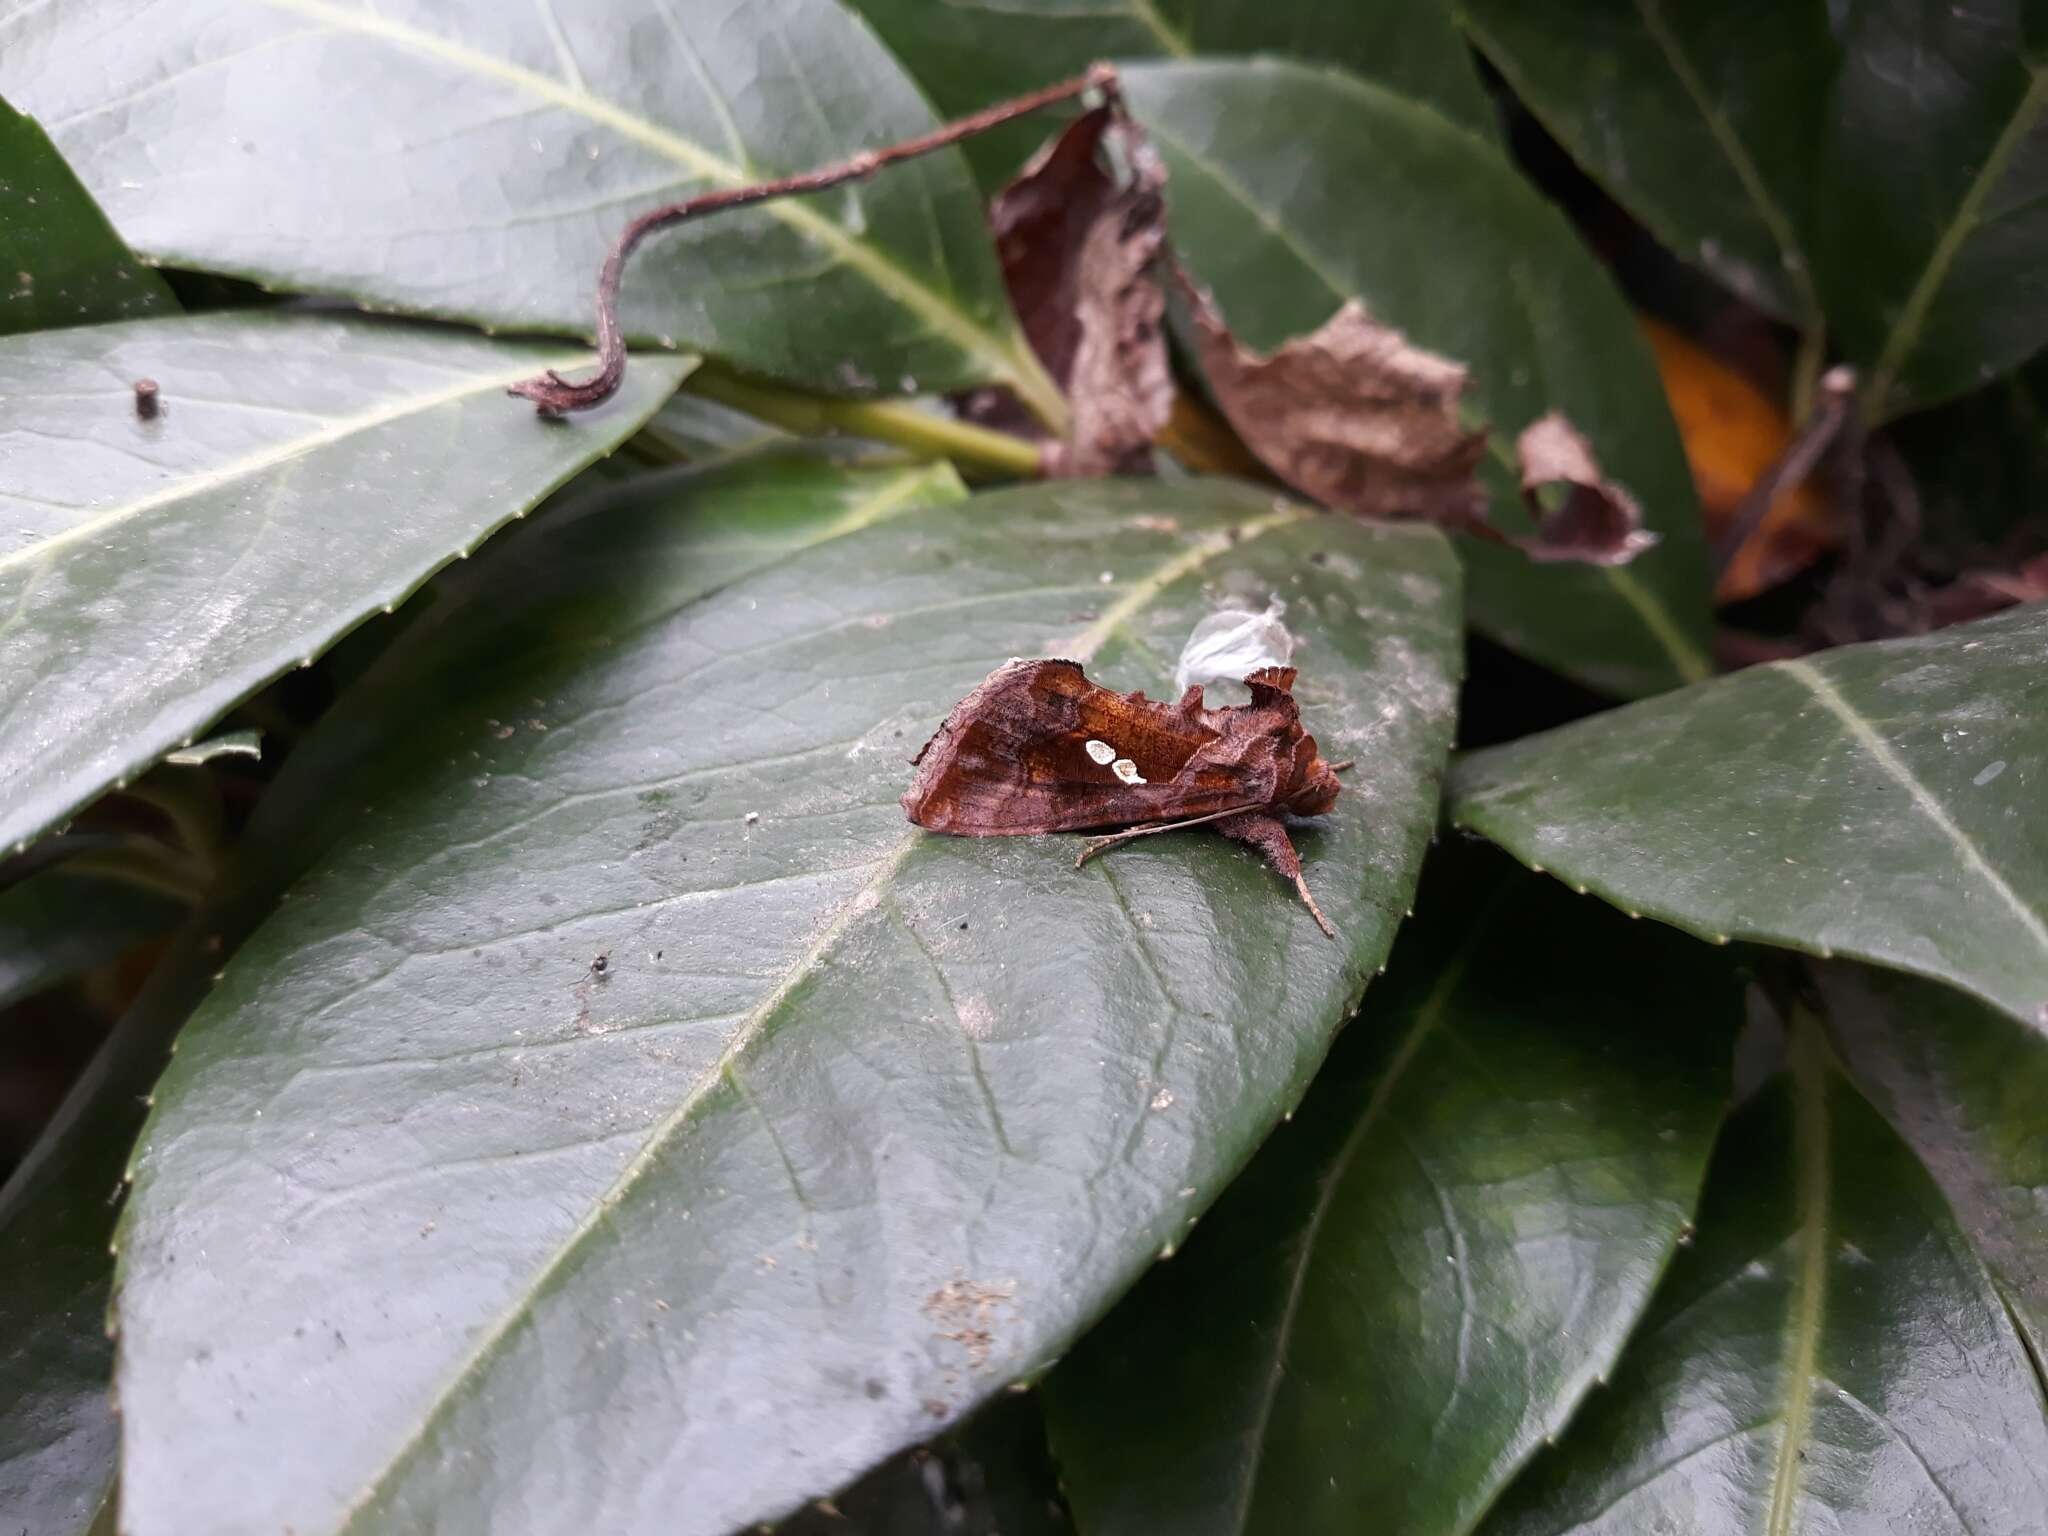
0,311,686,868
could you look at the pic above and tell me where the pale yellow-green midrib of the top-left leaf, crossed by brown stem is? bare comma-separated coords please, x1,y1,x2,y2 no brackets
260,0,1057,415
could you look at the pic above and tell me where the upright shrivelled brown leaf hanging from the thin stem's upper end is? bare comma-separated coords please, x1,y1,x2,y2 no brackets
989,106,1174,475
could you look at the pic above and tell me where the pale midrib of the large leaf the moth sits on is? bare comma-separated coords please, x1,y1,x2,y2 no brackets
338,506,1315,1532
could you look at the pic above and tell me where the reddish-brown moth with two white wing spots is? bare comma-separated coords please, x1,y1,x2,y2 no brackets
903,662,1350,938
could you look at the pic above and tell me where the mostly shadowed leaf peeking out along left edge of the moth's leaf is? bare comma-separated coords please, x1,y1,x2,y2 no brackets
0,442,948,1532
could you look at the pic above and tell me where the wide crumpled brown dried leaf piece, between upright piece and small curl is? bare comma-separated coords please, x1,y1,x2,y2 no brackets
1176,278,1487,528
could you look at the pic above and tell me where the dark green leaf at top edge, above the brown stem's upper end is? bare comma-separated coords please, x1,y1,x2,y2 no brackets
852,0,1497,190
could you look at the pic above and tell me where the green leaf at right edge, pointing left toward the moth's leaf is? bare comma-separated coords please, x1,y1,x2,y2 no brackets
1450,606,2048,1026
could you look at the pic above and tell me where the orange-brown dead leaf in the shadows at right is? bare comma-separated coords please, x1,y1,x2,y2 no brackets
1640,317,1841,602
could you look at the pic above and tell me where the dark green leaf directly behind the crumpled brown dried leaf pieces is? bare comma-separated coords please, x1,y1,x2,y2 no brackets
1124,61,1708,694
